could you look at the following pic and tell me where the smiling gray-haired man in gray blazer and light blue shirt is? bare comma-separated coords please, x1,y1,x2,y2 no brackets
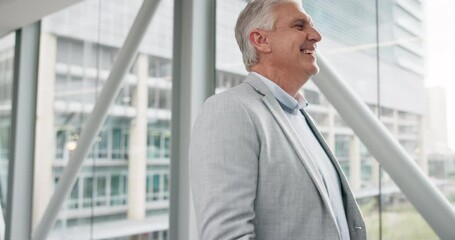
190,0,366,240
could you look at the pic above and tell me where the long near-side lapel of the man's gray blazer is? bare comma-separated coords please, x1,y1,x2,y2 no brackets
245,74,335,221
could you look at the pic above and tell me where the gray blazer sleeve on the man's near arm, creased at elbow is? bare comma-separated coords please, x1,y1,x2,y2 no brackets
189,94,260,240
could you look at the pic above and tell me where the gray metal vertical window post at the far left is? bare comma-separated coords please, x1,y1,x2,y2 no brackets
5,22,40,240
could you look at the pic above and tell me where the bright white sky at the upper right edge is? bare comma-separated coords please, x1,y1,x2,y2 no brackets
424,0,455,150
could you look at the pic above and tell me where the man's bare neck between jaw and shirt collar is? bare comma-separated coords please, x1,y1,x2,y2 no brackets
250,64,309,98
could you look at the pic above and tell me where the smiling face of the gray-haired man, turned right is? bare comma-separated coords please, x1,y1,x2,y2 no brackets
267,3,321,78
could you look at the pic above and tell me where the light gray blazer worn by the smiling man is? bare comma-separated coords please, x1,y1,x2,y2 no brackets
189,74,366,240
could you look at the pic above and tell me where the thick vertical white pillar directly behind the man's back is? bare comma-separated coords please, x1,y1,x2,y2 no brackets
169,0,216,240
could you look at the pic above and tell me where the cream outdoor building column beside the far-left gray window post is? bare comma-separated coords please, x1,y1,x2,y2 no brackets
32,33,57,229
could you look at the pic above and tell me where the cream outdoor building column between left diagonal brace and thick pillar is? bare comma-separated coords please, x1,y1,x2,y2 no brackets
128,54,148,220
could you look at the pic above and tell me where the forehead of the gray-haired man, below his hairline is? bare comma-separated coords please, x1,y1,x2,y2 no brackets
275,3,312,24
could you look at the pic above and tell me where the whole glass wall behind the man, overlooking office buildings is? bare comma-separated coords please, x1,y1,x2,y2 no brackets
0,0,455,240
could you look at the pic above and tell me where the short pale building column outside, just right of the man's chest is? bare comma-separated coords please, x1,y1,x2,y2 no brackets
349,135,361,191
